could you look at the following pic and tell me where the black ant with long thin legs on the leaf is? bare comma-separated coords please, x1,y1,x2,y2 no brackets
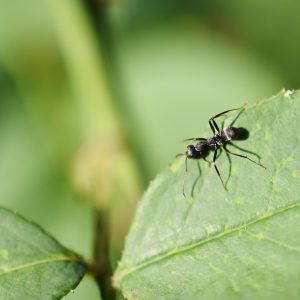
179,108,266,197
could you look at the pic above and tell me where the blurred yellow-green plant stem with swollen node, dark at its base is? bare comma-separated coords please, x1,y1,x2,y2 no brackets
49,0,141,300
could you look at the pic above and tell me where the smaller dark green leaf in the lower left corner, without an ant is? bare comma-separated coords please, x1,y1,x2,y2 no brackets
0,208,86,300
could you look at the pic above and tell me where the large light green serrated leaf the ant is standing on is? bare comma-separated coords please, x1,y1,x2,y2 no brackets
114,92,300,299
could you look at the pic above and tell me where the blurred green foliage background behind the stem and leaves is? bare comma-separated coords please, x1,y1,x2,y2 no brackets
0,0,300,299
